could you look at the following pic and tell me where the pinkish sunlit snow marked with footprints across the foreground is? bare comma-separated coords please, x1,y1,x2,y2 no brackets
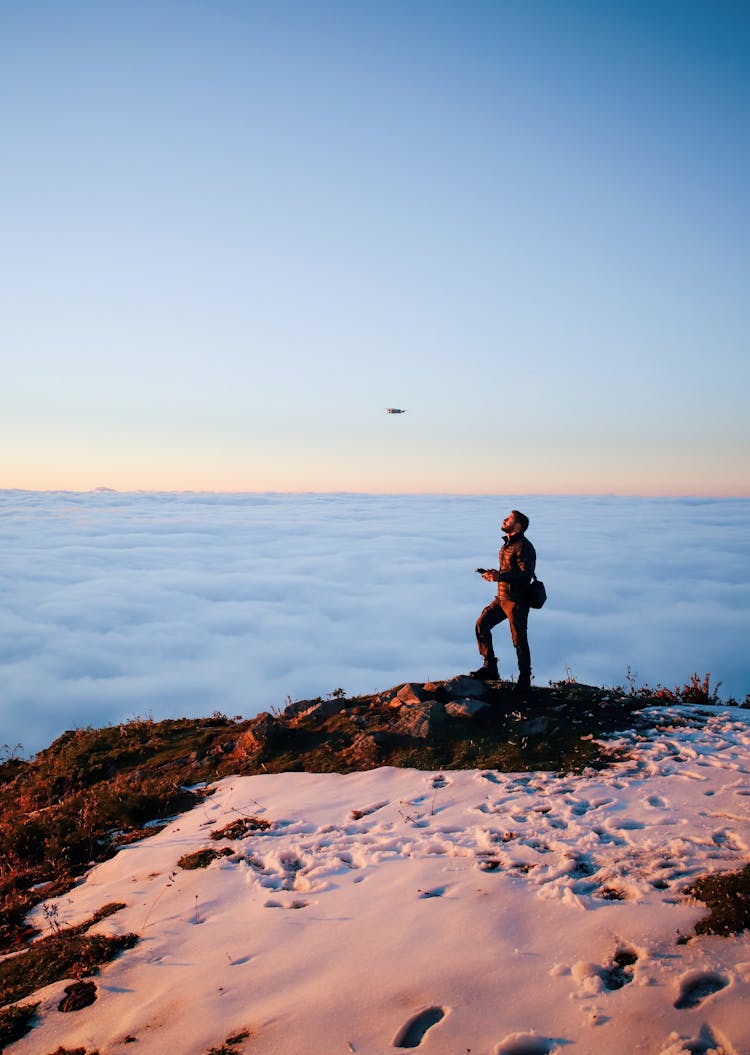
8,707,750,1055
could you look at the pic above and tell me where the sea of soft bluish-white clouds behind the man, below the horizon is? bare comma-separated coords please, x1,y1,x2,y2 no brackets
0,491,750,754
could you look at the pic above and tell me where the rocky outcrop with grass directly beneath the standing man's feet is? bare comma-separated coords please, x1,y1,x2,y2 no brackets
220,674,635,773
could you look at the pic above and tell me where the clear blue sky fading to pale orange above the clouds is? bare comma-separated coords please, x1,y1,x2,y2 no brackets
0,0,750,495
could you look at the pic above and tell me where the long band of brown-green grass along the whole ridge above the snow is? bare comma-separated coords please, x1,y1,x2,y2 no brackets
0,674,738,953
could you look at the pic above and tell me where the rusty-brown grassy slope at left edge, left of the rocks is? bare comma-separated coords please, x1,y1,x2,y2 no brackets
0,715,236,952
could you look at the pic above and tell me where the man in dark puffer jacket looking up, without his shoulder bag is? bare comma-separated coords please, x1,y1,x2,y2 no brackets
472,510,537,695
